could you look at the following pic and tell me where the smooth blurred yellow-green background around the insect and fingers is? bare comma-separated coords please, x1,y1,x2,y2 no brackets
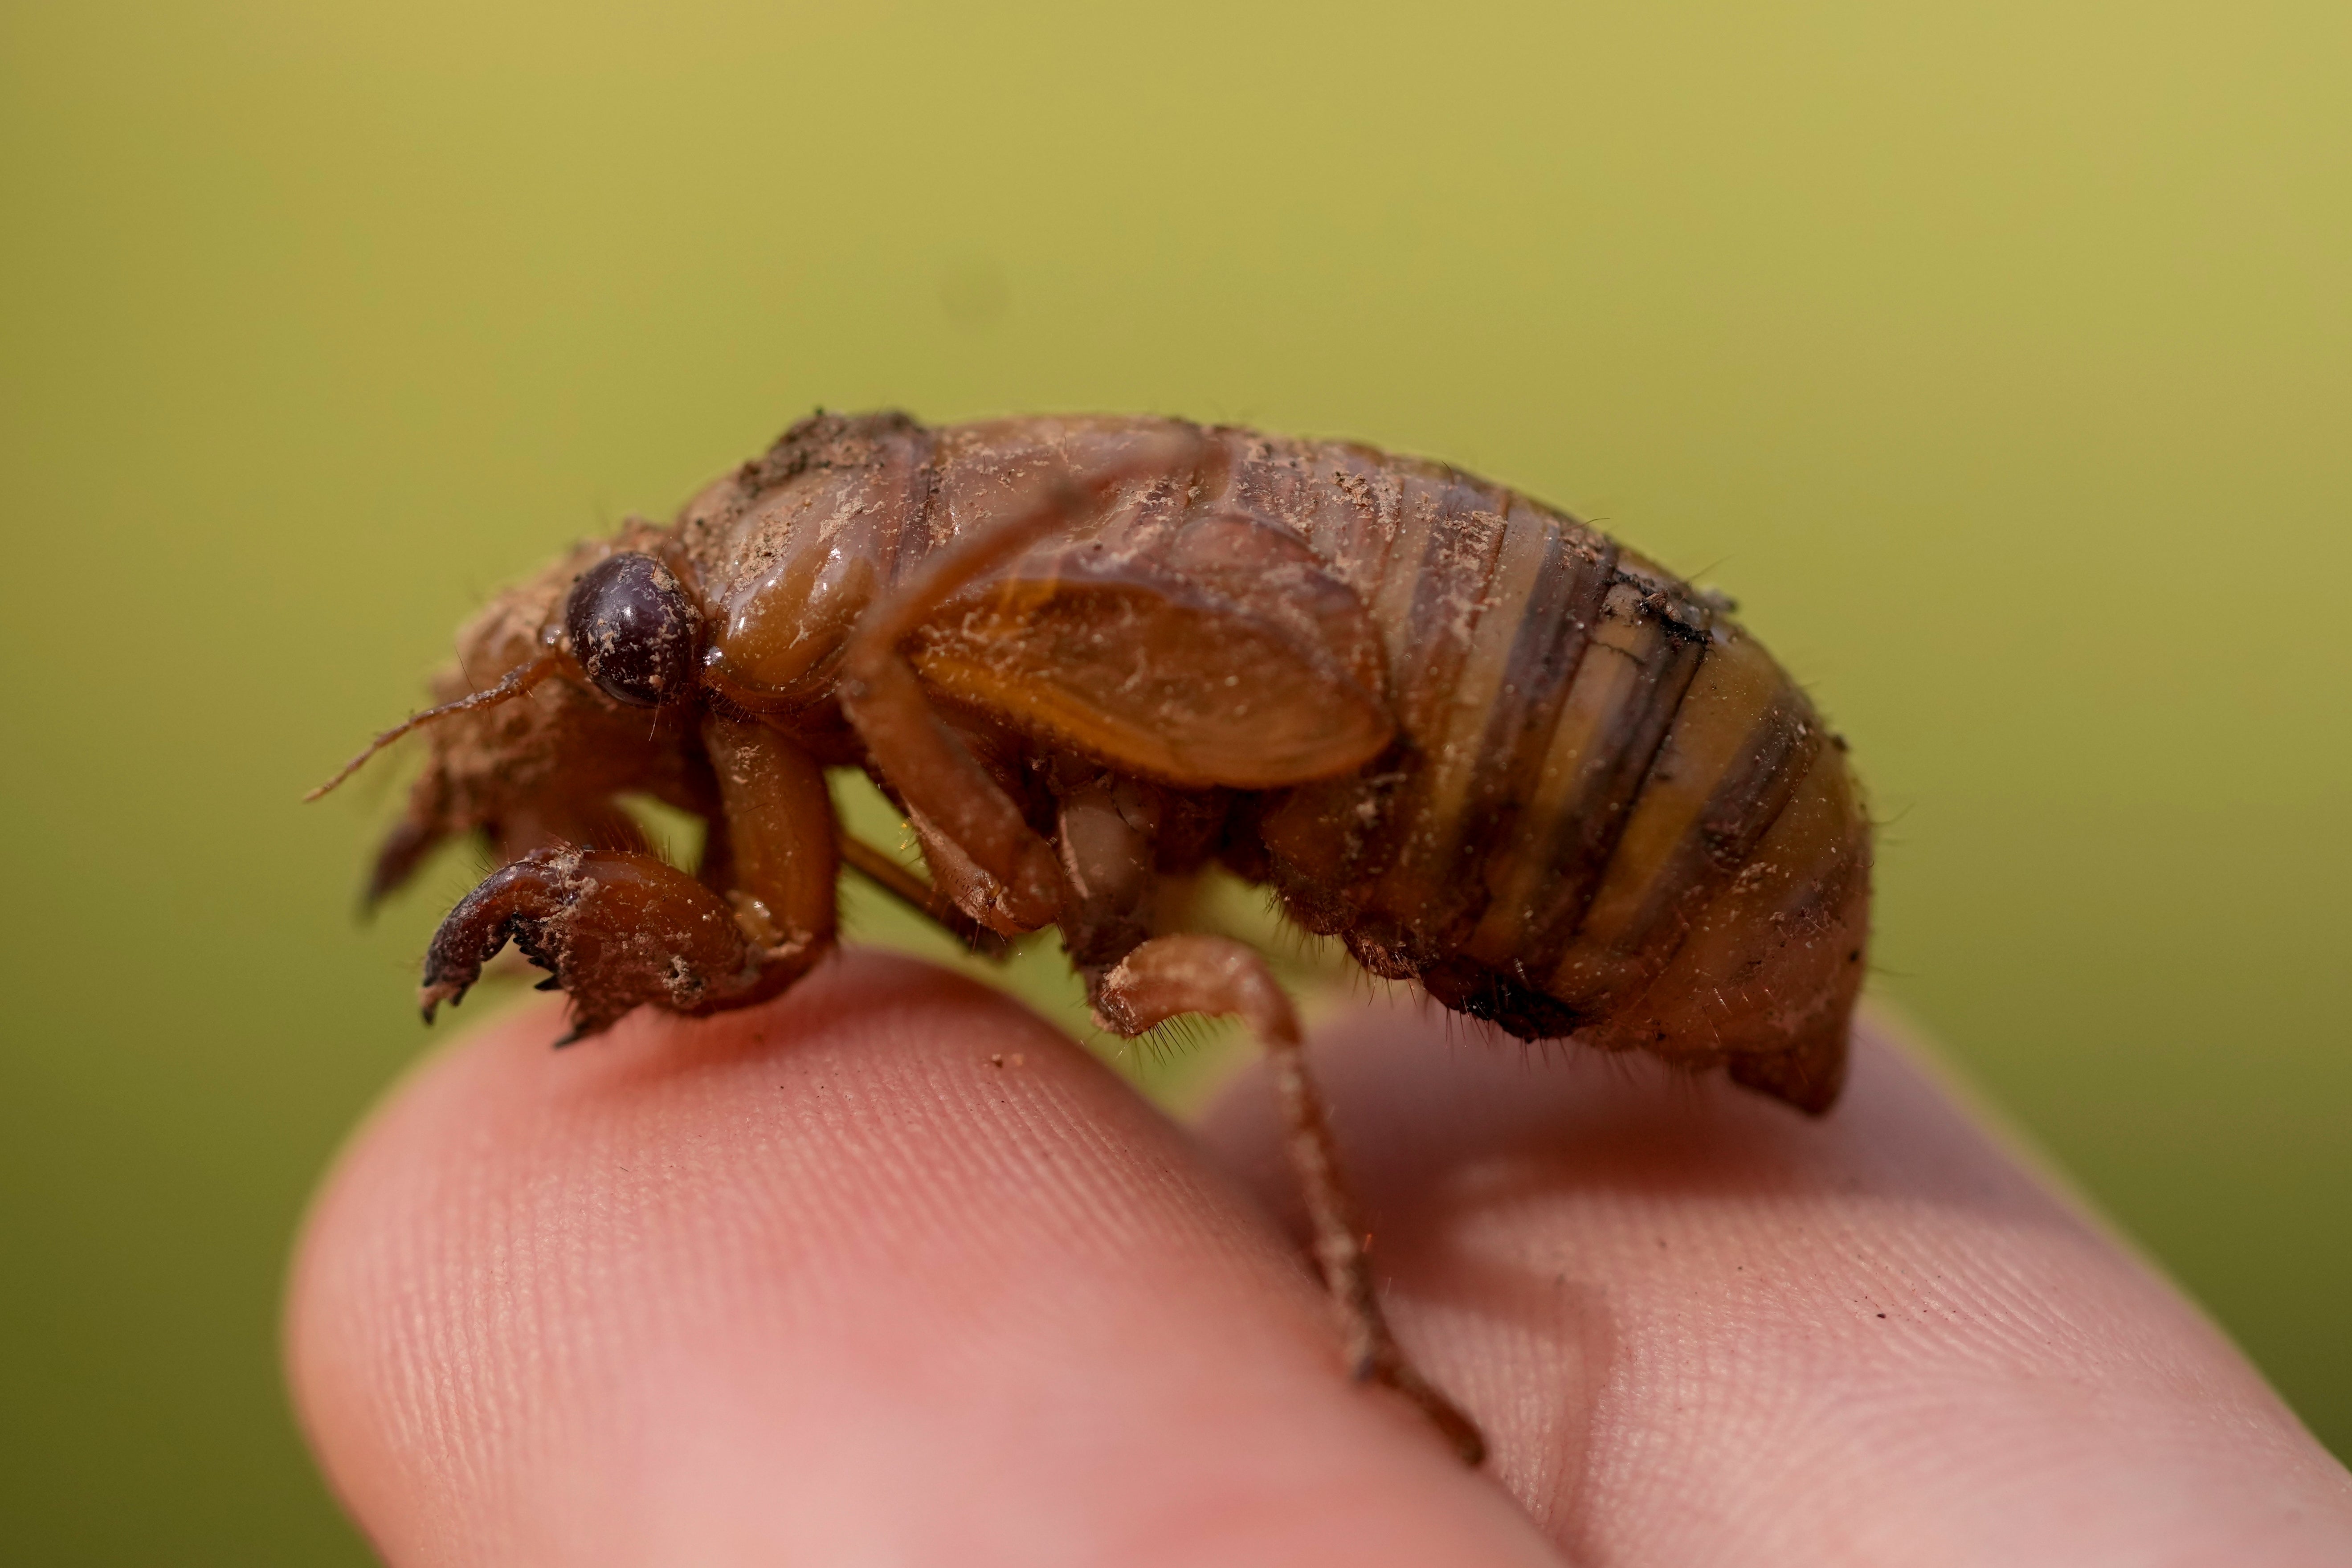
0,0,2352,1563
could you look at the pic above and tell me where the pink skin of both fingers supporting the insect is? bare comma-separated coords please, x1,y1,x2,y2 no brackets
289,955,2352,1568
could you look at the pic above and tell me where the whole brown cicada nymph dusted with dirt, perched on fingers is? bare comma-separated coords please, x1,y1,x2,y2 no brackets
329,414,1870,1462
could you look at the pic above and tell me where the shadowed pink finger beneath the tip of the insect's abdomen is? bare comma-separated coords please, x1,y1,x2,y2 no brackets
1204,1006,2352,1568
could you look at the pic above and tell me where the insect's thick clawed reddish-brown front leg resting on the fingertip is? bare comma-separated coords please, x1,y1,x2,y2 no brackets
421,717,837,1039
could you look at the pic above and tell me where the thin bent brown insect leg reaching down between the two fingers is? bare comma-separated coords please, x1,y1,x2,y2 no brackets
1089,935,1486,1465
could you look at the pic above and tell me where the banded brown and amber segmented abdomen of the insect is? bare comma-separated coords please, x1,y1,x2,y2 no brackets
1221,433,1870,1105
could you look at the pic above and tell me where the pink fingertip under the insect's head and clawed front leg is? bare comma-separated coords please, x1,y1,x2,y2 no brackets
289,957,1552,1568
